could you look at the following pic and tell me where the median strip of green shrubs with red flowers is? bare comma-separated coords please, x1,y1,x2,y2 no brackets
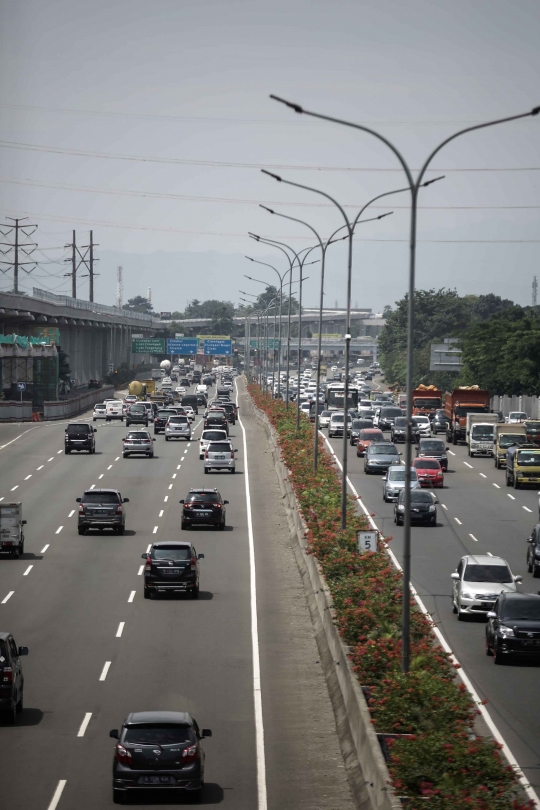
249,385,532,810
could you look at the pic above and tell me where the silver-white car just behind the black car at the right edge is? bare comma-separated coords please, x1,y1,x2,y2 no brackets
451,554,523,620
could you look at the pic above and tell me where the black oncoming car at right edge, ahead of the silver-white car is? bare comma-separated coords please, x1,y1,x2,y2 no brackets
486,593,540,664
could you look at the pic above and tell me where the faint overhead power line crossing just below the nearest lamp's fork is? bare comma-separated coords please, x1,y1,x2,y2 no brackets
0,177,540,210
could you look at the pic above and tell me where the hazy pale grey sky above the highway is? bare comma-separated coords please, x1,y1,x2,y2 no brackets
0,0,540,309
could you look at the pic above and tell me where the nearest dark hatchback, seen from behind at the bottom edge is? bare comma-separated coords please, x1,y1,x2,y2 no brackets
109,712,212,804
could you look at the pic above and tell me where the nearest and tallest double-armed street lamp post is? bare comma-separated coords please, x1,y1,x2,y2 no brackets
271,90,540,672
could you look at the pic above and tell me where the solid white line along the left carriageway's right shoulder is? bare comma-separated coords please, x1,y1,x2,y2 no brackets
237,380,267,810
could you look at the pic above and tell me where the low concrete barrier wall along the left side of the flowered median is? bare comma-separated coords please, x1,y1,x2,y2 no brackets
254,407,402,810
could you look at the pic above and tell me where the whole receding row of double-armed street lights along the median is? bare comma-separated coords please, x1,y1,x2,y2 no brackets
246,95,540,672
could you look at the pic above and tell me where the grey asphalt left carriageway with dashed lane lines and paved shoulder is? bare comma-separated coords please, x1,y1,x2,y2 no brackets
0,383,353,810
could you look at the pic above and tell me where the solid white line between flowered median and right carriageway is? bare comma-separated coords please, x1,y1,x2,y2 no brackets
320,432,539,807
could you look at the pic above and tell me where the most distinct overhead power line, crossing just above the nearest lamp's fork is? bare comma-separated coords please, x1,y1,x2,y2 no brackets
0,141,540,174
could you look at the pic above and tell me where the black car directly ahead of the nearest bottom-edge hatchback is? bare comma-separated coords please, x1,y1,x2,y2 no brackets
141,541,204,599
